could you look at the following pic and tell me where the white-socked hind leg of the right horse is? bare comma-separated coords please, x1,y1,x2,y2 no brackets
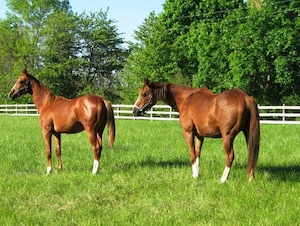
220,138,234,183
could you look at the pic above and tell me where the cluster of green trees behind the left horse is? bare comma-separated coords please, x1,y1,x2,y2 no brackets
0,0,128,102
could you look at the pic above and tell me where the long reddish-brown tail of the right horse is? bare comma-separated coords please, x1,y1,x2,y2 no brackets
245,97,260,181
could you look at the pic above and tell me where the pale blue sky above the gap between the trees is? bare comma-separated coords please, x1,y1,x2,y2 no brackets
0,0,165,42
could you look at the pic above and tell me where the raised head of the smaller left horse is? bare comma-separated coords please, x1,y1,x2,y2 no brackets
8,69,32,100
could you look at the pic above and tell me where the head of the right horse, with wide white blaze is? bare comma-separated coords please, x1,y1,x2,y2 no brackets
133,79,157,116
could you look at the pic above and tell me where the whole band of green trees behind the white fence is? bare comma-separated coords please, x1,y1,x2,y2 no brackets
0,0,300,105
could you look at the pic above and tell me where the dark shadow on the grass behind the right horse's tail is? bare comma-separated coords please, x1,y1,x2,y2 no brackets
233,164,300,182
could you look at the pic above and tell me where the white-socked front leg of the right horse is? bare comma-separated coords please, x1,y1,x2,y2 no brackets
184,131,201,179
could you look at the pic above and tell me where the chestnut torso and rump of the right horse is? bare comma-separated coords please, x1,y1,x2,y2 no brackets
180,89,250,137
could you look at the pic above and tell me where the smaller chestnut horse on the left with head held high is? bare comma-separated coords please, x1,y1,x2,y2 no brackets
9,69,115,174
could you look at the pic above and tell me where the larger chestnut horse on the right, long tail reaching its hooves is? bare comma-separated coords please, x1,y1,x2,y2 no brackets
133,79,260,183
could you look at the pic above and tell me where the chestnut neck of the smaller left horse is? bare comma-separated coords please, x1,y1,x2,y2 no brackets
31,80,55,112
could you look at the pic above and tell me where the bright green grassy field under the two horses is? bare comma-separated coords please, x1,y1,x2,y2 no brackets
0,116,300,225
